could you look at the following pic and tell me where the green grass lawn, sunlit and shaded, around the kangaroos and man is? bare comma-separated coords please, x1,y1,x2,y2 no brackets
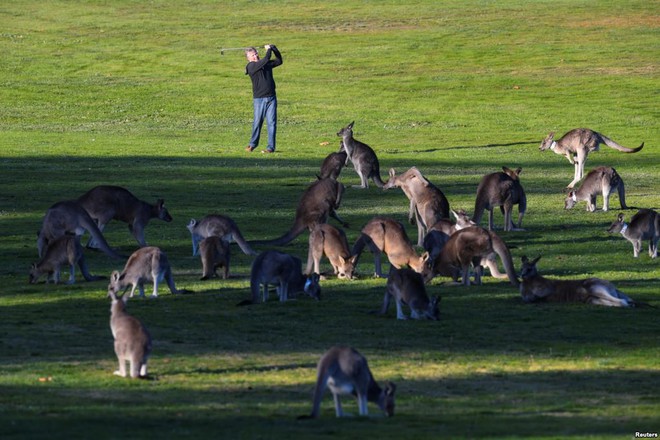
0,0,660,439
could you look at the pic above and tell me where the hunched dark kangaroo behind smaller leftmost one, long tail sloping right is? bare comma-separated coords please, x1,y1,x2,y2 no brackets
37,200,124,259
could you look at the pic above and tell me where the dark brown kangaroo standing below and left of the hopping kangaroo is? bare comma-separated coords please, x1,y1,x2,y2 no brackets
472,167,527,231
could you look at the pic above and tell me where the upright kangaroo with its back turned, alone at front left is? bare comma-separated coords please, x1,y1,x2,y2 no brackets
108,291,152,379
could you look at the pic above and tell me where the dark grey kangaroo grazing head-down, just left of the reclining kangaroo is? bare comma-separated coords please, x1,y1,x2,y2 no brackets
380,266,440,321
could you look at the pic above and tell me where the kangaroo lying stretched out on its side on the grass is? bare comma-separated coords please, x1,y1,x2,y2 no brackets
520,257,635,307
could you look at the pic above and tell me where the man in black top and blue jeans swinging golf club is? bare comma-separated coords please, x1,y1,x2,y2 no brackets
245,44,282,153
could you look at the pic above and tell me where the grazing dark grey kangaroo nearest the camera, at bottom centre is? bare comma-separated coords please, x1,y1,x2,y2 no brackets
298,346,396,419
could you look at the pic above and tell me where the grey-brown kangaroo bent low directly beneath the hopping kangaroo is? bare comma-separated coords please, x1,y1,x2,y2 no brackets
564,167,628,212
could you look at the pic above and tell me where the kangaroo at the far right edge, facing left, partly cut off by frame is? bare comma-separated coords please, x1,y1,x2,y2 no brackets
607,209,660,258
